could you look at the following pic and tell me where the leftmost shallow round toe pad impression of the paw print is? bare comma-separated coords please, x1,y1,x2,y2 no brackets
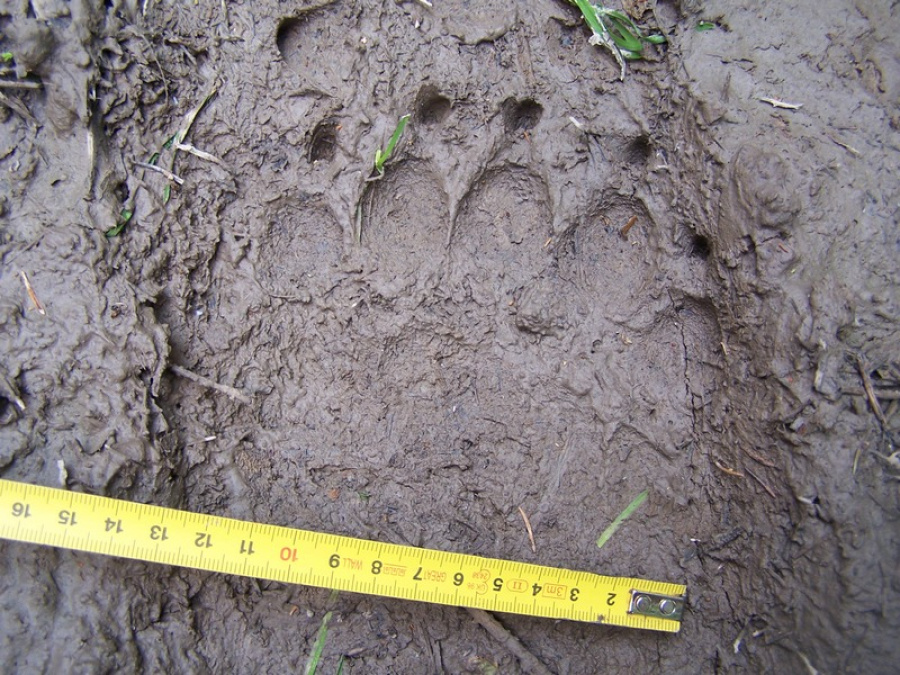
251,199,343,299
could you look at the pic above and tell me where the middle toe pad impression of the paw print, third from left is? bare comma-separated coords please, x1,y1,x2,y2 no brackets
450,166,552,303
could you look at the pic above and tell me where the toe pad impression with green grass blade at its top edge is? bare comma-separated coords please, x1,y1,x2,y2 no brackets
360,160,450,284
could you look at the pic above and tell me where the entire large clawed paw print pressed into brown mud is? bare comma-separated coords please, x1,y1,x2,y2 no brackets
174,3,724,554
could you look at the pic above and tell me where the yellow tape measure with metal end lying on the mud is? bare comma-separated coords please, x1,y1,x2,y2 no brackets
0,479,686,633
